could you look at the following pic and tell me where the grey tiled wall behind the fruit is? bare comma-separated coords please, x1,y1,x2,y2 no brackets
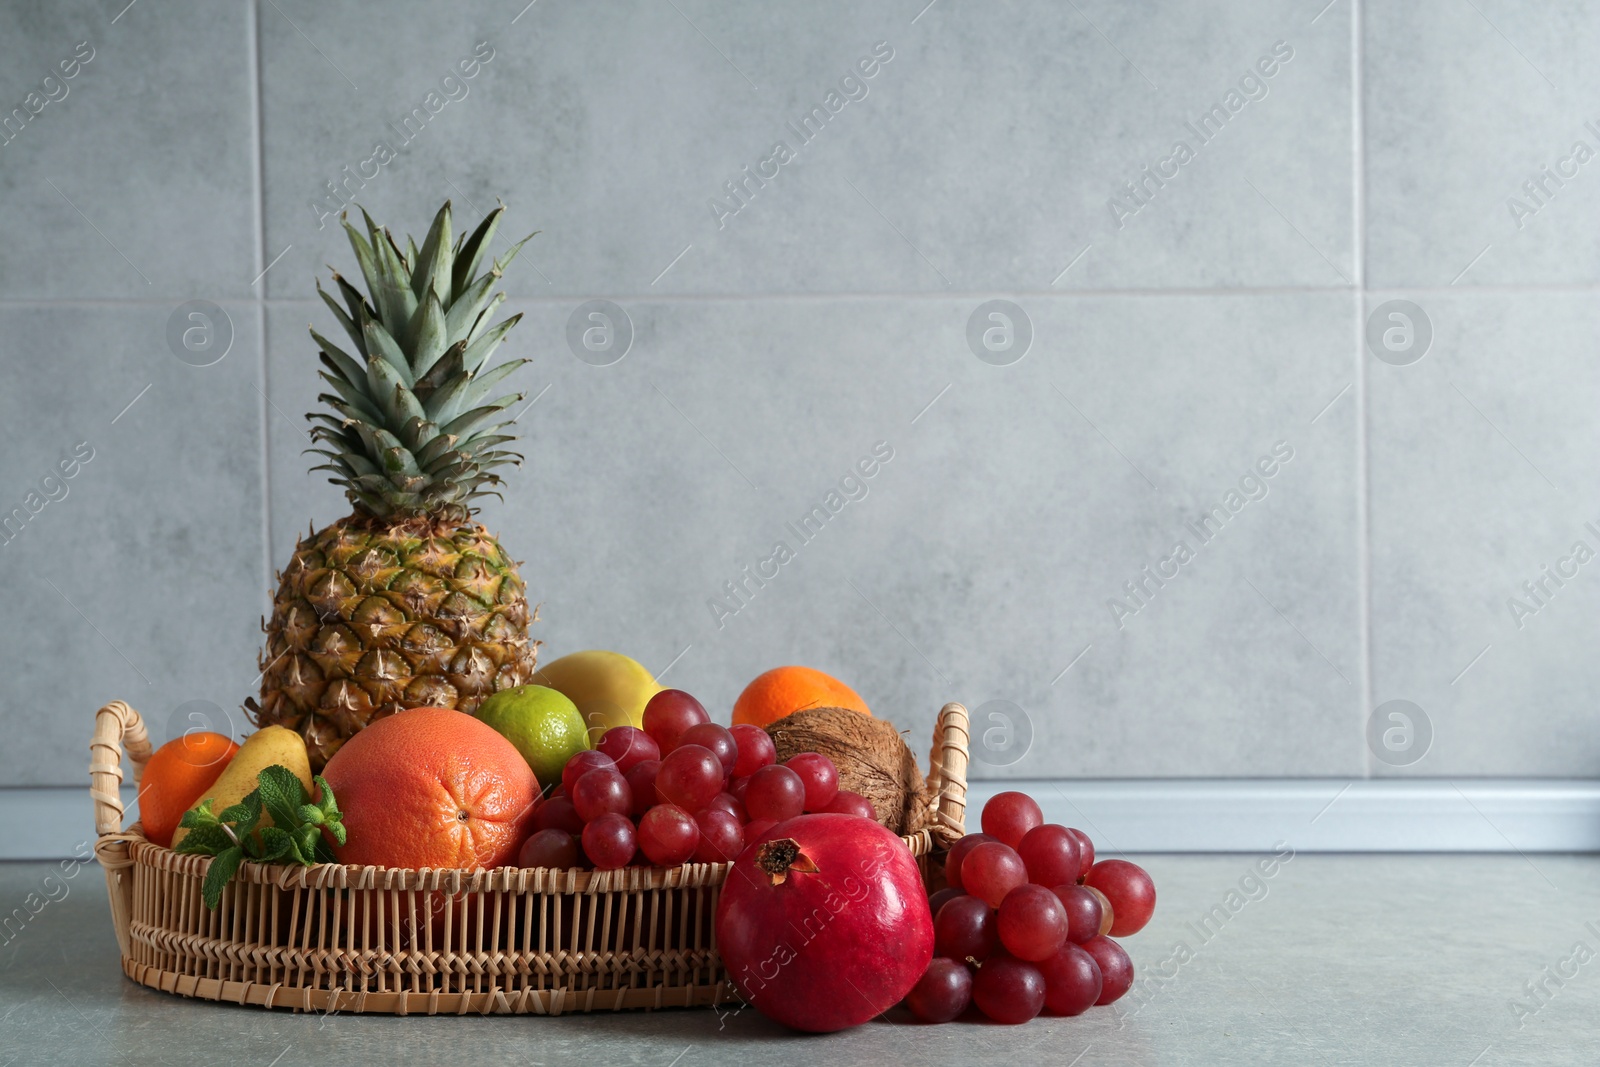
0,0,1600,785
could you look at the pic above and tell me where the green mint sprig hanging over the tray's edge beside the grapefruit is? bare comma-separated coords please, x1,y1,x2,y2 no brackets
178,765,346,912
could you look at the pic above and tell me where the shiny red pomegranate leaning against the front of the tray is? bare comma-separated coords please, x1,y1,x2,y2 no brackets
717,813,933,1033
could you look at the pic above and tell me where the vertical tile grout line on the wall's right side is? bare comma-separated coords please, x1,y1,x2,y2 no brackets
1350,0,1374,777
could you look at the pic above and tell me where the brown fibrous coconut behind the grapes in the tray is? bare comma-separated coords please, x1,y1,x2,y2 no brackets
766,707,934,833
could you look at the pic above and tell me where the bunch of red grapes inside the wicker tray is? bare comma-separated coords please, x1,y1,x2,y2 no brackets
518,689,877,870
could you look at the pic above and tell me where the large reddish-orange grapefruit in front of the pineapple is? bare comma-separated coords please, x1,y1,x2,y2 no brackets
322,707,539,869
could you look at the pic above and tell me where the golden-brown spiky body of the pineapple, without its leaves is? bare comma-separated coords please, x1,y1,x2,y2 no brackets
253,518,538,768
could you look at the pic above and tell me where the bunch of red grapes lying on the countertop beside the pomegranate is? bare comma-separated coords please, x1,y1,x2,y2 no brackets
906,792,1155,1022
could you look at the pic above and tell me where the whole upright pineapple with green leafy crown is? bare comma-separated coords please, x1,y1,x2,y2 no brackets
245,202,538,769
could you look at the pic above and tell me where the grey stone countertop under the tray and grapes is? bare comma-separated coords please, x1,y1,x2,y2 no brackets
0,854,1600,1067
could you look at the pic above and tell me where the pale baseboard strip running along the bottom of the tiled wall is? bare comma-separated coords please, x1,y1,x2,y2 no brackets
12,779,1600,861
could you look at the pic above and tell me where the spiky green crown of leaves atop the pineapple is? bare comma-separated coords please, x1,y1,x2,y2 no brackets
307,200,533,518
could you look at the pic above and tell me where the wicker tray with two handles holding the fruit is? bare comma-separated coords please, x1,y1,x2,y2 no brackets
90,701,968,1016
